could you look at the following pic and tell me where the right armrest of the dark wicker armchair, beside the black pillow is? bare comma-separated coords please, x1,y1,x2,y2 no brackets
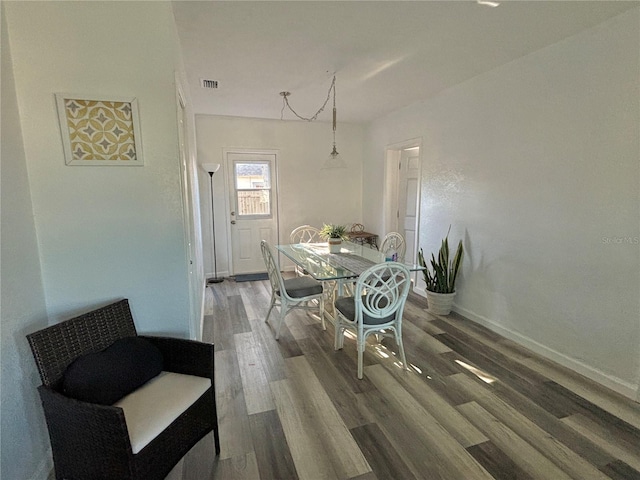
139,335,214,384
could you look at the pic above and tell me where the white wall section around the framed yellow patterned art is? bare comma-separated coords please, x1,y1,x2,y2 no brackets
6,1,189,336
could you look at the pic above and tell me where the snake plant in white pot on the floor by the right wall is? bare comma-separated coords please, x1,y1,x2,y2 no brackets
418,227,464,315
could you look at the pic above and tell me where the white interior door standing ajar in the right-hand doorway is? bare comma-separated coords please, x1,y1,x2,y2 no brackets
398,147,420,263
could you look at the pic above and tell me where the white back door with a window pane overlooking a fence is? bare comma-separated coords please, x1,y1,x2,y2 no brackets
227,152,278,275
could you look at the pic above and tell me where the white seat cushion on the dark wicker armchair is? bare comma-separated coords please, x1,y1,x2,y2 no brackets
113,372,211,453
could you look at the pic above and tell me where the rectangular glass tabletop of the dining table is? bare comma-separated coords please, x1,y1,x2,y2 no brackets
276,242,423,281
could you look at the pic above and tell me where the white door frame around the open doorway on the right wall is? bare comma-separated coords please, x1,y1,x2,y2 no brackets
382,137,426,290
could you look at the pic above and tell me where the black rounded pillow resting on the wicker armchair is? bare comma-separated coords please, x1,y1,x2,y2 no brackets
62,337,162,405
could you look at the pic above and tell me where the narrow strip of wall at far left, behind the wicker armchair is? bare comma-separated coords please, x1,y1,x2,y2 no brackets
0,5,51,479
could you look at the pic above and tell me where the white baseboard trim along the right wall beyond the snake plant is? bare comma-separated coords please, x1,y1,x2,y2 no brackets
453,303,638,401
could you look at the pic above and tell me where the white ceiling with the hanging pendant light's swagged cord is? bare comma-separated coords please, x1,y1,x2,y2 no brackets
173,0,640,122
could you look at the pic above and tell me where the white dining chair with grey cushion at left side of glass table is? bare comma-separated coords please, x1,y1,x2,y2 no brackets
260,240,327,340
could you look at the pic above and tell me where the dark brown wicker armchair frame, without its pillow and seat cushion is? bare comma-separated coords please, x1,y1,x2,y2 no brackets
27,299,220,480
